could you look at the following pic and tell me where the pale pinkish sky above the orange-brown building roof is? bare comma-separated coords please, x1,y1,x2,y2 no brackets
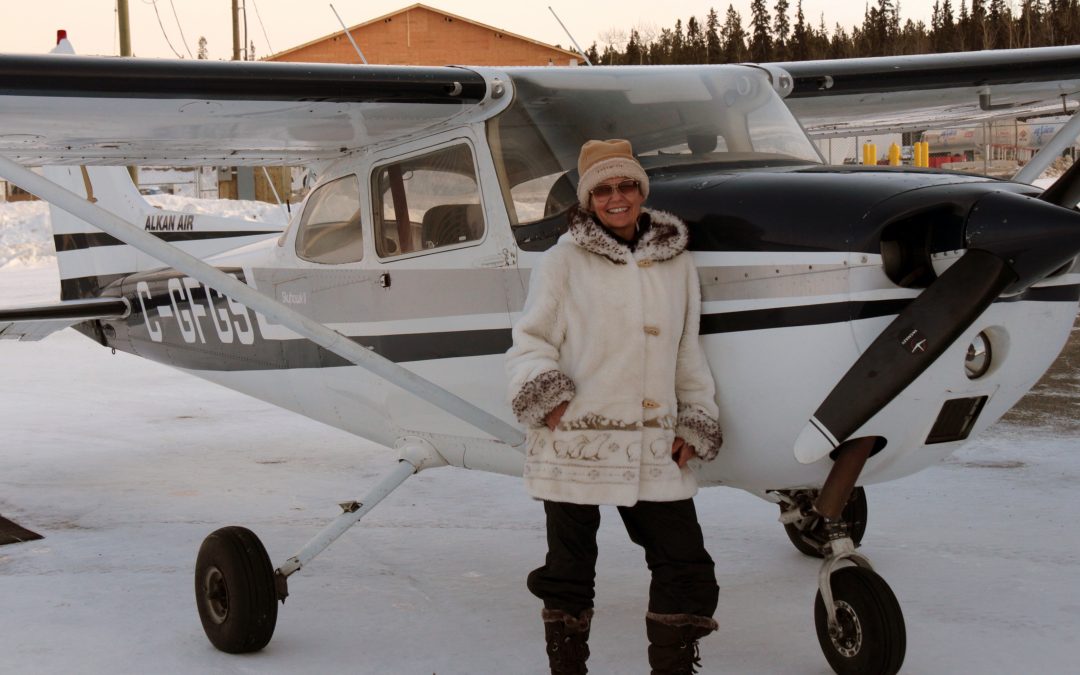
0,0,933,58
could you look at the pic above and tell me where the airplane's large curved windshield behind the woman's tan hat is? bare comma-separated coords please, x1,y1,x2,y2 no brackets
487,66,821,226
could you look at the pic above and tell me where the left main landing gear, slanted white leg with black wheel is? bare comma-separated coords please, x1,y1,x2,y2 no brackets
195,440,446,653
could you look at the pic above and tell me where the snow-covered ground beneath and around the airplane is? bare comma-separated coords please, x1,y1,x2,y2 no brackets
0,198,1080,675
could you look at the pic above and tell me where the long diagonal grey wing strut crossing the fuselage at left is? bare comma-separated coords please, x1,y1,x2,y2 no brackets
0,156,525,446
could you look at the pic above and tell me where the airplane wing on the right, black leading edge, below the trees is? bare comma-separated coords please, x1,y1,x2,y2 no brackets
765,46,1080,138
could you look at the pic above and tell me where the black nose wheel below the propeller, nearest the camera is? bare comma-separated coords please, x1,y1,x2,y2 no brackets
813,567,907,675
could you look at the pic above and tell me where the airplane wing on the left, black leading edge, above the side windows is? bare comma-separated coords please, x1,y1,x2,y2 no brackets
0,54,487,166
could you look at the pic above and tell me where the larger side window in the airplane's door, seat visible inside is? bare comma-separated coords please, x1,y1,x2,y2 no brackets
372,145,484,257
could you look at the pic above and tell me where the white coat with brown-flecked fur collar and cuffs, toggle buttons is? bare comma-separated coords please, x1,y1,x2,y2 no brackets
507,208,723,505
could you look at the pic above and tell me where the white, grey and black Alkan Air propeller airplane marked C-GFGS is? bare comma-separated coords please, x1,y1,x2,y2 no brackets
0,36,1080,674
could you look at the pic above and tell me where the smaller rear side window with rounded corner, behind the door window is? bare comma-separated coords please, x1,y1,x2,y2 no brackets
296,176,364,265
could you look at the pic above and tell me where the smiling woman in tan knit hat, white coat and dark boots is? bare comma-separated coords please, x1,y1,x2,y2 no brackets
507,139,721,674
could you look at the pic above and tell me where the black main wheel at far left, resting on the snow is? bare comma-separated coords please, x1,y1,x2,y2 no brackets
195,527,278,653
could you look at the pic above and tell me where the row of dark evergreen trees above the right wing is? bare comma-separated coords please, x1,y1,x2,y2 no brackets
585,0,1080,65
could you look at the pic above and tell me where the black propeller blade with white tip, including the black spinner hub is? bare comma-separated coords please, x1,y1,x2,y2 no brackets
795,190,1080,463
